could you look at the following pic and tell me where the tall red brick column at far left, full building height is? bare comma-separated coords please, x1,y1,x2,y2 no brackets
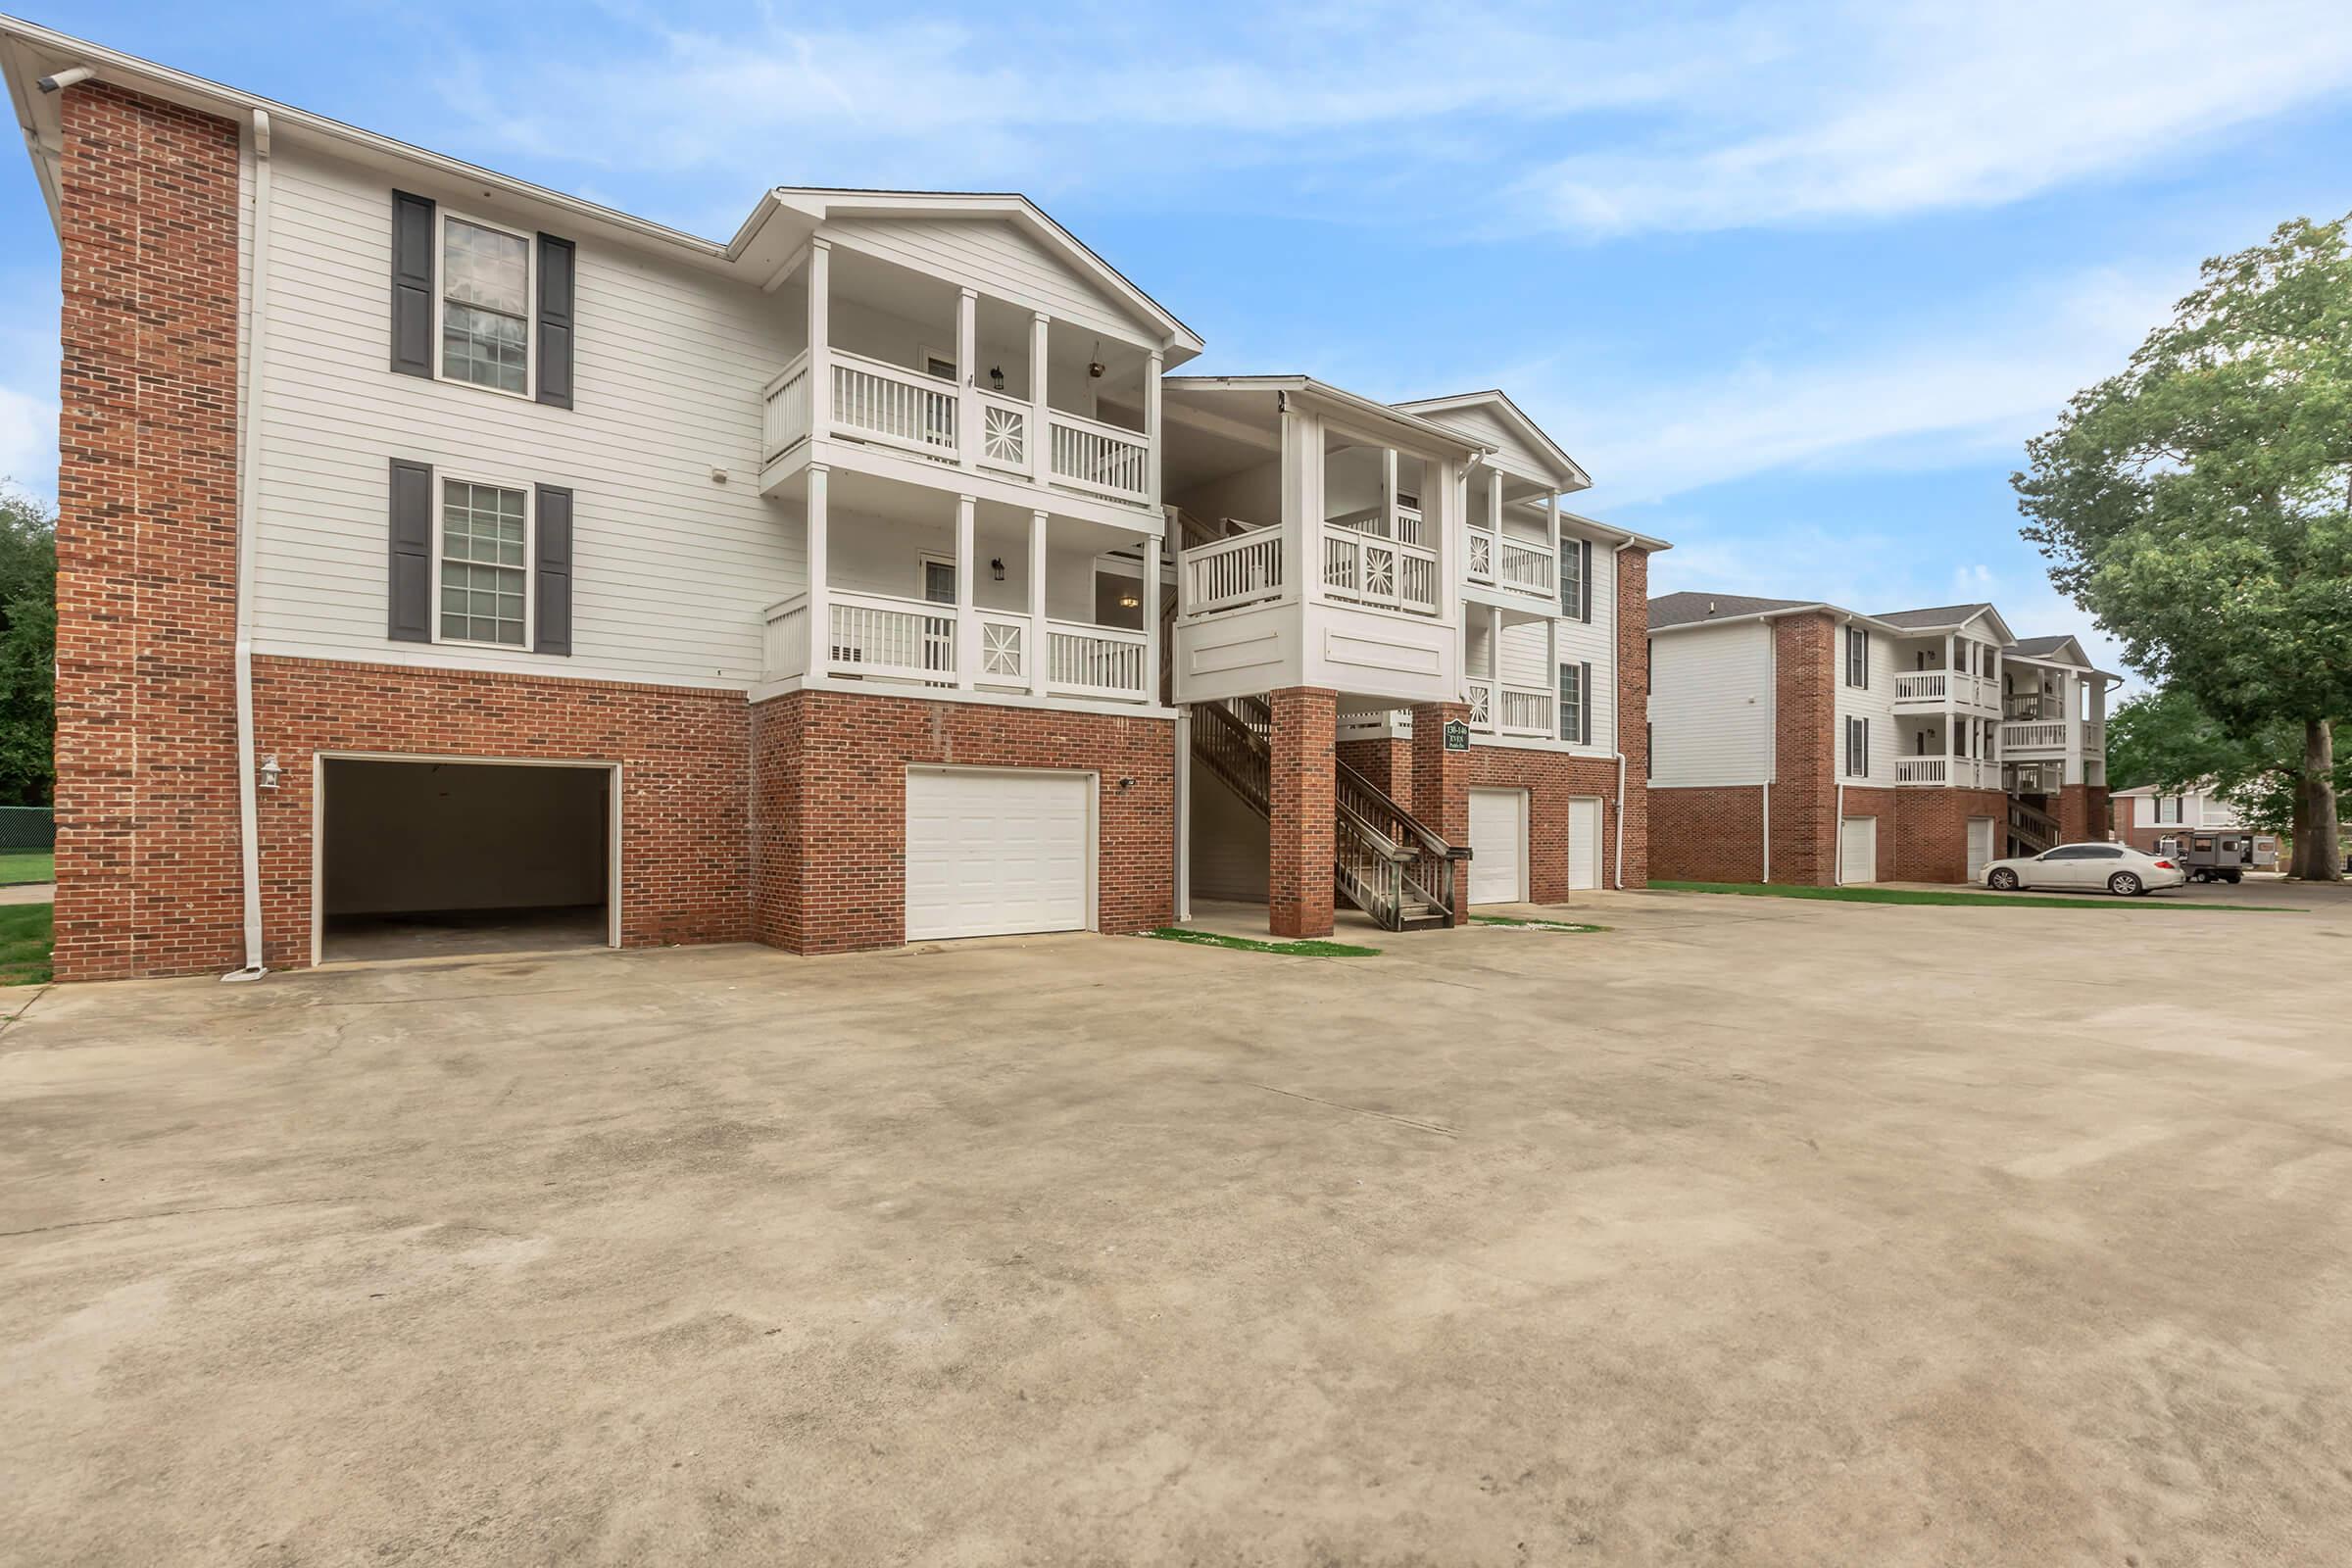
57,82,242,980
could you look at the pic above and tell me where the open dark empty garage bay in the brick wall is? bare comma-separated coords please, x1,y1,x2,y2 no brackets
319,757,612,959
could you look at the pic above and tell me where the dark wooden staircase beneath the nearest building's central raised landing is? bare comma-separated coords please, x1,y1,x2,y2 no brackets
1193,696,1470,931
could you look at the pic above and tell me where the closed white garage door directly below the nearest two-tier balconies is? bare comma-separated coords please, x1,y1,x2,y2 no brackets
906,768,1092,943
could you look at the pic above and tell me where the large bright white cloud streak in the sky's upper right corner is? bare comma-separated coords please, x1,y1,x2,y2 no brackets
1519,0,2352,235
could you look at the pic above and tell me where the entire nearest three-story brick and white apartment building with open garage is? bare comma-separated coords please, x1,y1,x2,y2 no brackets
0,22,1653,978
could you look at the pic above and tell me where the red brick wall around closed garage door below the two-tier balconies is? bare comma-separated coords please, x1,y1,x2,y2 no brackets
751,691,1176,953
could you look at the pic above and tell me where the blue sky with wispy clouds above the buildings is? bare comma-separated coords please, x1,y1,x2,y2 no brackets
0,0,2352,681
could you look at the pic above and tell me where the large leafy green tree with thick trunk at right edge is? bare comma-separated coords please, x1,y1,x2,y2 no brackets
2011,219,2352,879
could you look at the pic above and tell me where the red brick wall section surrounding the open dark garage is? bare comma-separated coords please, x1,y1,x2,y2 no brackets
250,659,751,968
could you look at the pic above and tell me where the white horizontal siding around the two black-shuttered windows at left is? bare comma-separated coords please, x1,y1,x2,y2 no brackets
257,141,800,684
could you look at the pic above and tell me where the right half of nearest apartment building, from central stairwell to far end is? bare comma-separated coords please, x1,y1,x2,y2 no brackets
1166,390,1668,933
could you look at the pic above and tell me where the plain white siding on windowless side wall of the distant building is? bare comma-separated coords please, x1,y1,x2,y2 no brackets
1648,620,1774,790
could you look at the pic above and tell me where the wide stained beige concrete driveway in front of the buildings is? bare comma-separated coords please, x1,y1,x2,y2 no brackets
0,894,2352,1568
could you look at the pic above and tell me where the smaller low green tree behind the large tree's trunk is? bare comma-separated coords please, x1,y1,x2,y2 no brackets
2107,689,2352,832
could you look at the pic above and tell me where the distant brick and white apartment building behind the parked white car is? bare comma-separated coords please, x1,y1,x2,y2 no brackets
1648,592,2117,886
